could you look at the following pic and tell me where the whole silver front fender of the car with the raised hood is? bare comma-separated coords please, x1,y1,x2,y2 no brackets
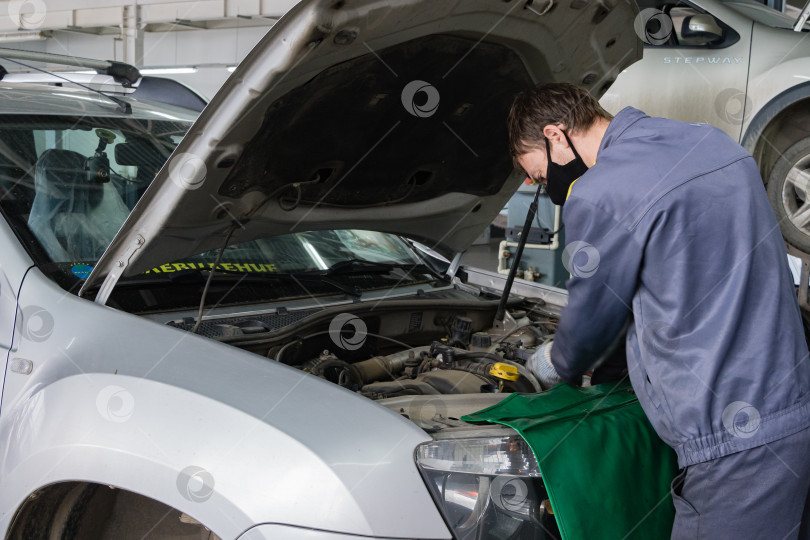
0,269,449,538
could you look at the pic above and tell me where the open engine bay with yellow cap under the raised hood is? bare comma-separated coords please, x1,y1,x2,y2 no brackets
169,290,557,400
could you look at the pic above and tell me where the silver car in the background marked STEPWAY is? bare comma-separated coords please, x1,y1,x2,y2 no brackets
601,0,810,254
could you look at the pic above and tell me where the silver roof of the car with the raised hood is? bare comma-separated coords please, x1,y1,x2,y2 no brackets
0,81,197,122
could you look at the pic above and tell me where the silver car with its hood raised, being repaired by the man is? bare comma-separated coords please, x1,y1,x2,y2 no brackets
0,0,641,540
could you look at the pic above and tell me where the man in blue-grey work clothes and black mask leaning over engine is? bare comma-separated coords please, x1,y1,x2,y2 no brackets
509,84,810,540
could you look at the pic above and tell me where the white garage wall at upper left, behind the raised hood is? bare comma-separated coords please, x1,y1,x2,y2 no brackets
0,0,297,99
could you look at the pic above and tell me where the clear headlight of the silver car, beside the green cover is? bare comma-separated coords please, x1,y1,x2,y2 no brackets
416,437,559,540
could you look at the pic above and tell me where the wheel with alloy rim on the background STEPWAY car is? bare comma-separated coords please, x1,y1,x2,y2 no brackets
768,137,810,253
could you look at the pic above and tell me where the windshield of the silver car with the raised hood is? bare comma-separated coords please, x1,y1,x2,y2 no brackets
0,115,436,310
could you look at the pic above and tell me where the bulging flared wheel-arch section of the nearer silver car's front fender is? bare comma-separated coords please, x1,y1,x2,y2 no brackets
0,373,358,538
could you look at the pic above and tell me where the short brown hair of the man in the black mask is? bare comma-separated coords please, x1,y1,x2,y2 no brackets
509,83,613,169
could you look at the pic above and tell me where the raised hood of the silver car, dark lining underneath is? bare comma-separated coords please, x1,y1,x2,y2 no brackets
82,0,642,303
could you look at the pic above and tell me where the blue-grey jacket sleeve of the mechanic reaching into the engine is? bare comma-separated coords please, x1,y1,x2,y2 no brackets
551,198,643,385
